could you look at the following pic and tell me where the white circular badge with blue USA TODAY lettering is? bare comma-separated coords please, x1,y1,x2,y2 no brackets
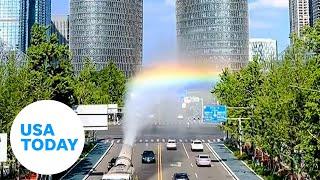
10,101,85,175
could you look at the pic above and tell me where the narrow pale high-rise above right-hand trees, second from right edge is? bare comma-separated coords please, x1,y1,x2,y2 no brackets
289,0,310,35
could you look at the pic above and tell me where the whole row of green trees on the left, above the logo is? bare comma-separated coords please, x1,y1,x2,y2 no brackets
0,25,126,179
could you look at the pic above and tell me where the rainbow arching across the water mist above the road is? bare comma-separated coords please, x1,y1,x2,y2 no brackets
130,63,221,87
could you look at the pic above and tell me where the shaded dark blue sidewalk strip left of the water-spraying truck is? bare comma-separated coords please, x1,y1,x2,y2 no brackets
62,142,111,180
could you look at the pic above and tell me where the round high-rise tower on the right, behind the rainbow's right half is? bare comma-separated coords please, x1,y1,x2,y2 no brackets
176,0,249,70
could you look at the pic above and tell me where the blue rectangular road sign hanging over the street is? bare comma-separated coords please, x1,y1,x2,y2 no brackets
203,105,227,123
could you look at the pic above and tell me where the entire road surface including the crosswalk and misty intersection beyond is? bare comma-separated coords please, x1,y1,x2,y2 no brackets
88,121,233,180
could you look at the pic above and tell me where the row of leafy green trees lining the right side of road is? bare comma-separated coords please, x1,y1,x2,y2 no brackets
213,23,320,179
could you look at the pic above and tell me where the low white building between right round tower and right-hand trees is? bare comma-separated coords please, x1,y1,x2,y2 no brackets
249,39,278,62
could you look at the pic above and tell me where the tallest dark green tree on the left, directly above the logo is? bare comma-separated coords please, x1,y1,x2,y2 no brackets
27,24,76,106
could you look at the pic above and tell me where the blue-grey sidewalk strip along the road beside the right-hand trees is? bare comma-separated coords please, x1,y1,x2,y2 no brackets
210,143,260,180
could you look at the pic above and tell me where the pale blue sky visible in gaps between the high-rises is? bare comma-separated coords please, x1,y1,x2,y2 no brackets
51,0,290,64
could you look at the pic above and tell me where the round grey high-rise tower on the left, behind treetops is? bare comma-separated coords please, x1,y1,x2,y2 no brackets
69,0,143,77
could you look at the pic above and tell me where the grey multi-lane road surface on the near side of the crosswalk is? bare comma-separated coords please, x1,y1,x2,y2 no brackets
88,143,233,180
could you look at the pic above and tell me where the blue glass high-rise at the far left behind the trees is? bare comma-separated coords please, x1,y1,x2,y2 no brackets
0,0,51,52
